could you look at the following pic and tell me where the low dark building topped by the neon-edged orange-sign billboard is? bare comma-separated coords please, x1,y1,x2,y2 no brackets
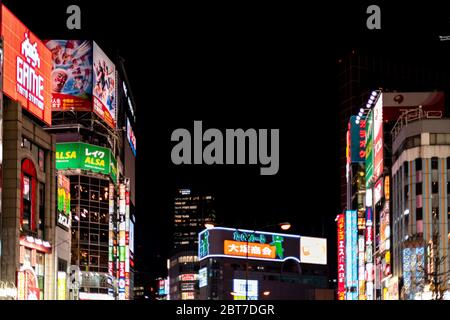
198,227,334,300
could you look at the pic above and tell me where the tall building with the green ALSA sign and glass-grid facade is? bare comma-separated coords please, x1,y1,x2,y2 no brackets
46,40,136,300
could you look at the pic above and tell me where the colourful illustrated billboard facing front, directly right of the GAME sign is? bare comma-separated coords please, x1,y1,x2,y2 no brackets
45,40,92,111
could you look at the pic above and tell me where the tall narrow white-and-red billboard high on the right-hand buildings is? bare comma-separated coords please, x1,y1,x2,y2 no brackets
373,94,384,181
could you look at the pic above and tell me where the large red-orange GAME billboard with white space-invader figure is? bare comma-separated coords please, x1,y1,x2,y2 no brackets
1,6,52,126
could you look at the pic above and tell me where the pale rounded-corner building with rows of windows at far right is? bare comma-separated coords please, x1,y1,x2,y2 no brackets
391,109,450,300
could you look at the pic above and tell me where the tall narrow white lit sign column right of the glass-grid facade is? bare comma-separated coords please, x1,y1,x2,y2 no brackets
118,183,126,300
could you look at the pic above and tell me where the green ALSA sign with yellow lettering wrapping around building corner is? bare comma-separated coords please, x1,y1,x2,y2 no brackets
56,142,117,183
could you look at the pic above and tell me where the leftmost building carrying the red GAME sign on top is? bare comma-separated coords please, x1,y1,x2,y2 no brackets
0,6,57,300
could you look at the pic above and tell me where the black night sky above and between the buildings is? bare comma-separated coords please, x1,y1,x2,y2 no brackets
4,0,450,277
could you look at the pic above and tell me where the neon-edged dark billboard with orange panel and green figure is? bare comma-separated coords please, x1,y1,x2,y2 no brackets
198,227,300,262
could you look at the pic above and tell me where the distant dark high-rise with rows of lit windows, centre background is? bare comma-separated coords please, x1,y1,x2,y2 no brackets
173,189,216,248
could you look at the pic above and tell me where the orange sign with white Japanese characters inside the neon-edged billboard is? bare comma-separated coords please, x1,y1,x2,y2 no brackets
223,240,276,259
